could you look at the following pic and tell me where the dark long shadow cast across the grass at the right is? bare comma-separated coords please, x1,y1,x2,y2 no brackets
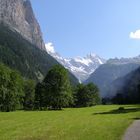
93,108,140,115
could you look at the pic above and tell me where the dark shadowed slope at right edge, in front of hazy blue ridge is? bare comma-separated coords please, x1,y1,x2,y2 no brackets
110,67,140,104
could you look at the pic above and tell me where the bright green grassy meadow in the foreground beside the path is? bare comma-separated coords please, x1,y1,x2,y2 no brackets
0,105,140,140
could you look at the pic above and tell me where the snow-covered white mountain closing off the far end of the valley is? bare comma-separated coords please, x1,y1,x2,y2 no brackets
46,43,106,82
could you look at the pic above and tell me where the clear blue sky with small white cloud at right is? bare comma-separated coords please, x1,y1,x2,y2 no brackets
31,0,140,58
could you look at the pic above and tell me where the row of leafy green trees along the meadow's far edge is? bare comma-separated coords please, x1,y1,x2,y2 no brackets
0,64,101,112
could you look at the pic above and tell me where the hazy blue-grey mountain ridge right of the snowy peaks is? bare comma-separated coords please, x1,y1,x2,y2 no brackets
85,56,140,97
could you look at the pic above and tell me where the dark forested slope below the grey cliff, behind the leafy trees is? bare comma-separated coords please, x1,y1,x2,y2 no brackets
0,23,78,85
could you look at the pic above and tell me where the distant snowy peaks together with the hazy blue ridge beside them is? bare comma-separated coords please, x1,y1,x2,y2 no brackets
46,43,140,98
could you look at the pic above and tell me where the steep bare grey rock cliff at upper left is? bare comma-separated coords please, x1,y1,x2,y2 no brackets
0,0,45,49
